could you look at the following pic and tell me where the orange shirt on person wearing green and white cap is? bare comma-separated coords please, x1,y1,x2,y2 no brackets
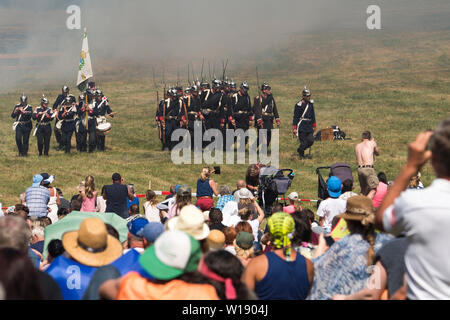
117,272,219,300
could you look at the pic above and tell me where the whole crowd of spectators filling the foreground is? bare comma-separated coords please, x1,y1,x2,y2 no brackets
0,119,450,300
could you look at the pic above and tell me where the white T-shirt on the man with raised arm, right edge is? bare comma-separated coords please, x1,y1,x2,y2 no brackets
383,179,450,300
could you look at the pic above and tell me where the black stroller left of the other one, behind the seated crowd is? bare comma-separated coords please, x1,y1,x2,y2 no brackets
258,166,294,217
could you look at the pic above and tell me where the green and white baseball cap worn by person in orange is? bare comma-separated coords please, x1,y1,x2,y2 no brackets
139,230,202,280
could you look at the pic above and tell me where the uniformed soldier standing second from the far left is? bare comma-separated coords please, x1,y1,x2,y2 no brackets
33,96,53,156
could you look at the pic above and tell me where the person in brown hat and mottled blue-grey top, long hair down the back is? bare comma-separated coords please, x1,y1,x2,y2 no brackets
308,196,392,300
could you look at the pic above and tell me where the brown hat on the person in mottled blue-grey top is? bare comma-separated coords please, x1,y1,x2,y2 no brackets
337,196,375,226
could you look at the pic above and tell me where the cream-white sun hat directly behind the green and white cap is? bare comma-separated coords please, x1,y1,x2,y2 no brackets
167,205,209,240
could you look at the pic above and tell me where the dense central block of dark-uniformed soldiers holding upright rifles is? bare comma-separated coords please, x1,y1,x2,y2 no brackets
155,79,280,150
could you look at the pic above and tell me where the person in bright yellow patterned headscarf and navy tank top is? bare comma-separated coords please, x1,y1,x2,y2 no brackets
243,212,314,300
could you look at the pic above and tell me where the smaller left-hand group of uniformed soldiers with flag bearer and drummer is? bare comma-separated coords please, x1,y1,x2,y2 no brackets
11,82,114,157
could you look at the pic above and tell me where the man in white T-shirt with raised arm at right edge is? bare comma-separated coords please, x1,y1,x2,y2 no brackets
376,118,450,300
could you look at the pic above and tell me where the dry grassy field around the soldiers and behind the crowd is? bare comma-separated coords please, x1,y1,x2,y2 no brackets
0,31,450,210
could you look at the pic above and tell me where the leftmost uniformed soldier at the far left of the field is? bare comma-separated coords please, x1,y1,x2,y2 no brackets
11,94,33,157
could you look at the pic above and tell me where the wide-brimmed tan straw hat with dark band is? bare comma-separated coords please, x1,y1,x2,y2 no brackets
62,218,122,267
